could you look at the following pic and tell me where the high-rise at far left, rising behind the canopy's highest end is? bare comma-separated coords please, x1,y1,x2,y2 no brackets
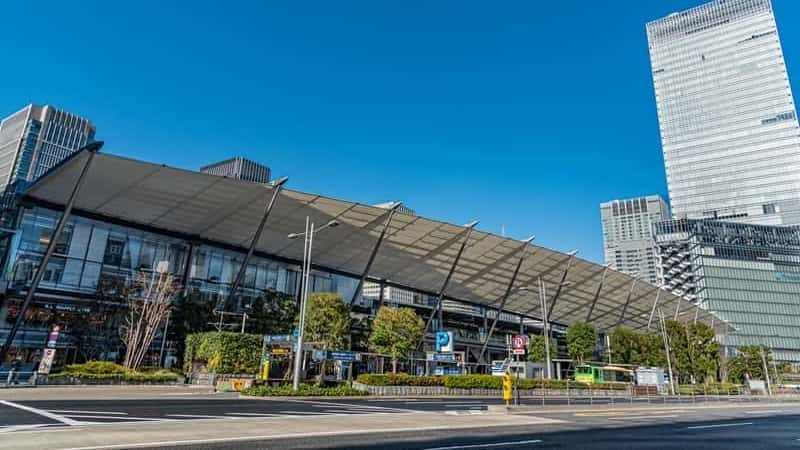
0,104,95,189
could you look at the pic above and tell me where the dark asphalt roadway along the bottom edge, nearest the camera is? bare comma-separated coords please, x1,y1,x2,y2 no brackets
180,415,800,450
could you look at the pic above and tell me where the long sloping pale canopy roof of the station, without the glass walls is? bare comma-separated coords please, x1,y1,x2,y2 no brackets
25,151,725,330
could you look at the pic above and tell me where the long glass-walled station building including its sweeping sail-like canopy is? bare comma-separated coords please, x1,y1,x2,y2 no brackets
0,150,724,371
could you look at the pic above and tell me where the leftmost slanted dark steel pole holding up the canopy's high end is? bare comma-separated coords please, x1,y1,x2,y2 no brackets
0,141,103,363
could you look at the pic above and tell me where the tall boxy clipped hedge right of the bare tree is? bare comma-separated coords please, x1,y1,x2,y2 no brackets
183,331,262,374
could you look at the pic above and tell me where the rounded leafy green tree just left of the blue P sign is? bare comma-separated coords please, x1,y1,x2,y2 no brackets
369,306,425,373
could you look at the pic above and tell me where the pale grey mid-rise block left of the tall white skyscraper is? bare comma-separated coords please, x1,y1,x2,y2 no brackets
600,195,669,284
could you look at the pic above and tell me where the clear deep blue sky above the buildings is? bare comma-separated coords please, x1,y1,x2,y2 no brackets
0,0,800,261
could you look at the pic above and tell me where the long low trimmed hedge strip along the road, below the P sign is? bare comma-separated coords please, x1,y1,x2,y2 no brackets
356,374,628,391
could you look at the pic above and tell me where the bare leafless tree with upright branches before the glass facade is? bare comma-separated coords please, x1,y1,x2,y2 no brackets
120,271,179,370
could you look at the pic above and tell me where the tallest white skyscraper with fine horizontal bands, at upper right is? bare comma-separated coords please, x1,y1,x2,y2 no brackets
647,0,800,225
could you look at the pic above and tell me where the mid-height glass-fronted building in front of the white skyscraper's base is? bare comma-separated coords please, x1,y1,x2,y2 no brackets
655,220,800,363
